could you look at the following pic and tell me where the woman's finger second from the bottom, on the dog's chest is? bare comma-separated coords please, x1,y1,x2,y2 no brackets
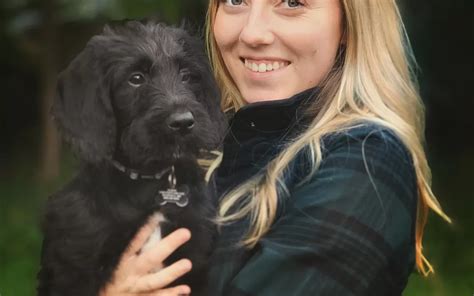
130,259,192,295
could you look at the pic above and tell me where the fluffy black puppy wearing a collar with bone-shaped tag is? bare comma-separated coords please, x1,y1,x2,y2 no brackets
38,21,225,296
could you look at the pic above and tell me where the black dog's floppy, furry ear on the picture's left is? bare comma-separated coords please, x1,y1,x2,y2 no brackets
51,37,116,163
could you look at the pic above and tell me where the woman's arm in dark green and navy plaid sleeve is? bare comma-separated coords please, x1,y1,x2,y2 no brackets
220,128,417,296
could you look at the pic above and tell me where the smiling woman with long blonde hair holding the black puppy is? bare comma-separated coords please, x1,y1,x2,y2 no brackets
102,0,449,295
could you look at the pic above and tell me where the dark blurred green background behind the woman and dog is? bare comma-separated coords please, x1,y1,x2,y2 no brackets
0,0,474,296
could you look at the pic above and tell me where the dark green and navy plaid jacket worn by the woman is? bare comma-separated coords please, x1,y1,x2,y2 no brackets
209,89,417,296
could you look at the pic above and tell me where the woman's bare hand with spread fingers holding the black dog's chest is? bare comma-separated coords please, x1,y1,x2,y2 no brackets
100,218,192,296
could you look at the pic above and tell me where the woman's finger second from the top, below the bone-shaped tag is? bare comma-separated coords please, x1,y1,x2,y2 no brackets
137,228,191,273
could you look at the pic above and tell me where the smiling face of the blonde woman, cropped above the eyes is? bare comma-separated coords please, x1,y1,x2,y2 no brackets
213,0,342,103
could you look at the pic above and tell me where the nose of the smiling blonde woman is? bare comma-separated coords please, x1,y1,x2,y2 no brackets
239,5,274,47
